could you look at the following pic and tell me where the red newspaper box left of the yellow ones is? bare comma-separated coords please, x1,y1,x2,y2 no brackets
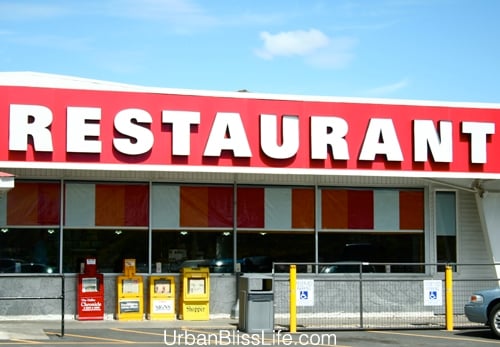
76,258,104,320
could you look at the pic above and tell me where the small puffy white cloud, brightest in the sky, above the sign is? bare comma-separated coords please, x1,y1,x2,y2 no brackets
255,29,357,68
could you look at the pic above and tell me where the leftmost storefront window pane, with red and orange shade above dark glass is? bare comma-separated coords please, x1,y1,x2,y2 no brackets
0,181,61,273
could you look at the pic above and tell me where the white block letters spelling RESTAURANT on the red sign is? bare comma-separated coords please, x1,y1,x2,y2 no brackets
9,105,495,163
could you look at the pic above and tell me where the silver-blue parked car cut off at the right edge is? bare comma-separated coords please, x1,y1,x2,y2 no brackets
464,287,500,338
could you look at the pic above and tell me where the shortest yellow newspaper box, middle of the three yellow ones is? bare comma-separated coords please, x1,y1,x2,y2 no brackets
149,276,175,320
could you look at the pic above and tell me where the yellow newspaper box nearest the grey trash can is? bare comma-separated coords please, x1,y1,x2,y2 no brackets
179,267,210,320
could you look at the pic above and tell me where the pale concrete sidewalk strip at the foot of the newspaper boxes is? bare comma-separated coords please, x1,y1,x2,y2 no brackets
0,318,238,340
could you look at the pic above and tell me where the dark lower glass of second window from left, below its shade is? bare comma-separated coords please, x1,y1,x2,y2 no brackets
63,229,149,273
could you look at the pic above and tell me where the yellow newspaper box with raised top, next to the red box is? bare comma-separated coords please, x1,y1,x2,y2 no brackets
116,259,144,320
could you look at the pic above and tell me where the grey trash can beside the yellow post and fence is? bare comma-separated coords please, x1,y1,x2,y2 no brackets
238,274,274,333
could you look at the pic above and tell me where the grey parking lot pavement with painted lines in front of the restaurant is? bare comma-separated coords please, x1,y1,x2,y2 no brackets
0,319,500,347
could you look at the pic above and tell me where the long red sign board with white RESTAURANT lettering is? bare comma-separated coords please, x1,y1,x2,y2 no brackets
0,86,500,177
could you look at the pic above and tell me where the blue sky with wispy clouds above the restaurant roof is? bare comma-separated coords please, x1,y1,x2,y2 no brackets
0,0,500,103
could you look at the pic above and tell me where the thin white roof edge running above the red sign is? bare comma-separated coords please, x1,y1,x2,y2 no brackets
0,71,500,109
